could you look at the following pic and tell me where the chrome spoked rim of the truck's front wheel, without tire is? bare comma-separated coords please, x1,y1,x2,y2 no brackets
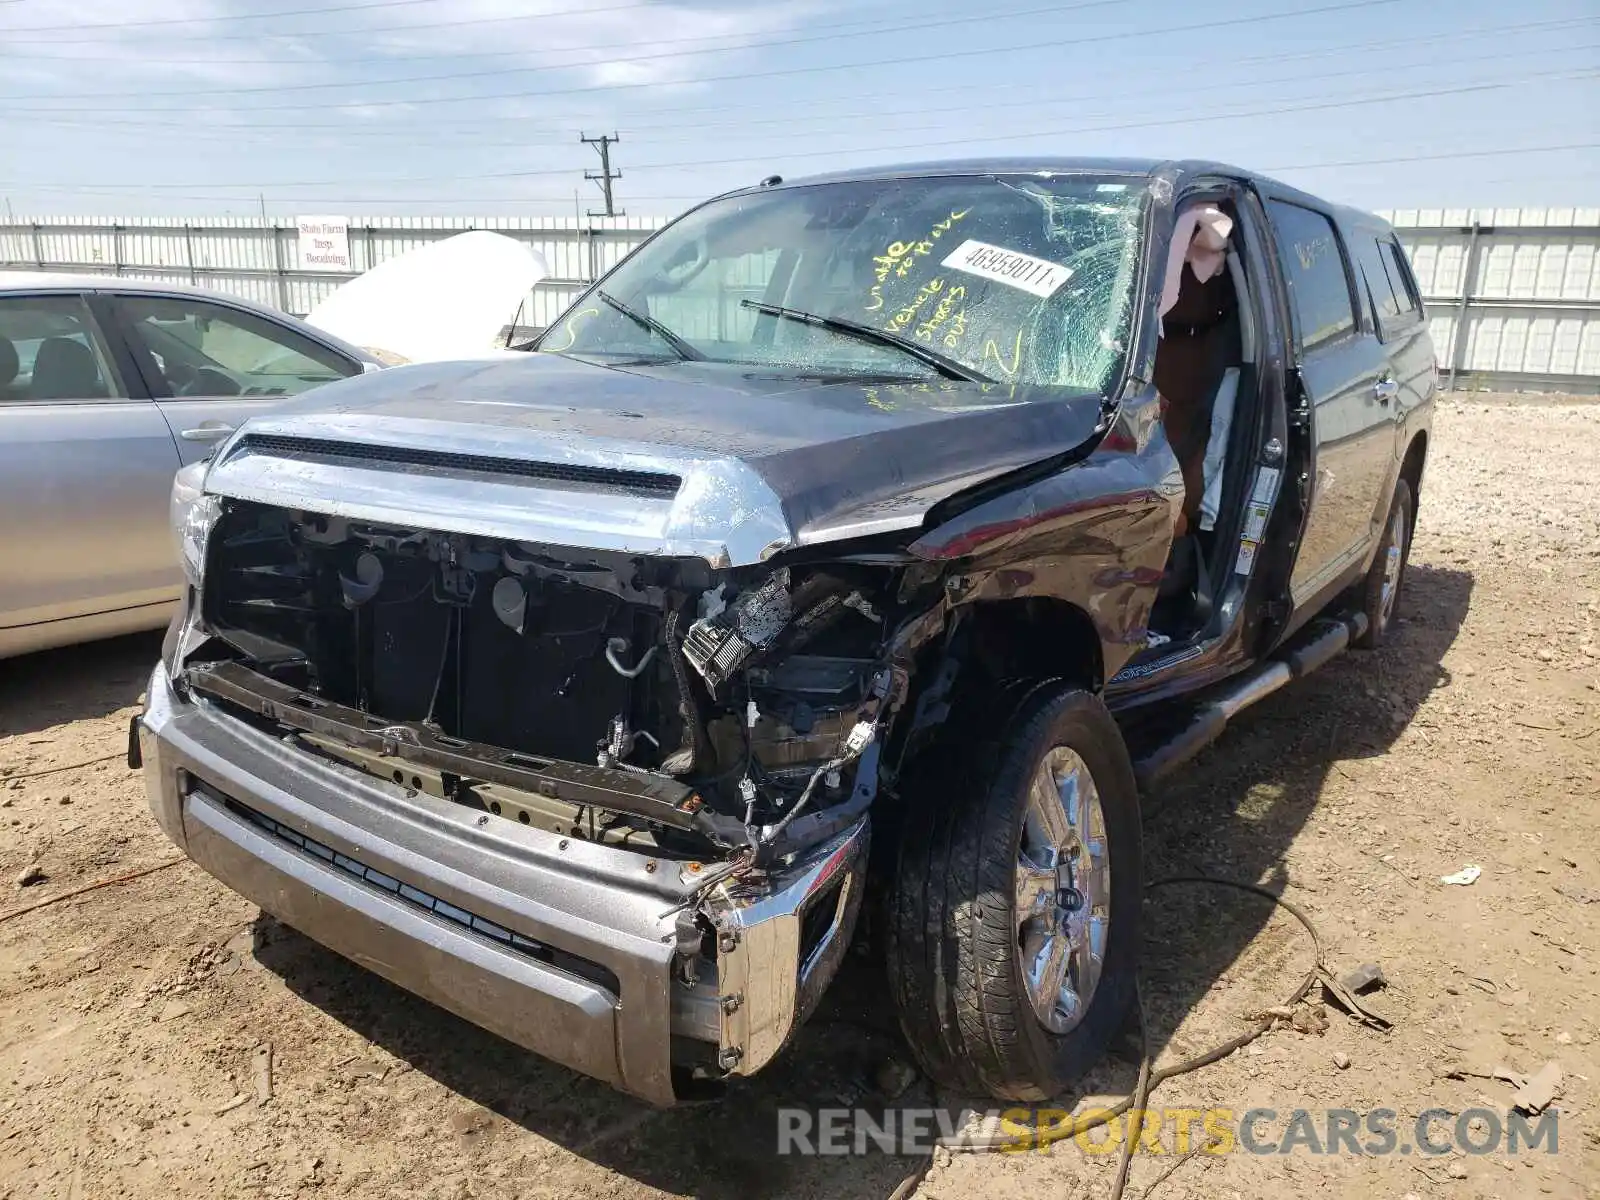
1016,746,1110,1034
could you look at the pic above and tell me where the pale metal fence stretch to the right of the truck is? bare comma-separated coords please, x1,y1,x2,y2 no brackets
1384,208,1600,392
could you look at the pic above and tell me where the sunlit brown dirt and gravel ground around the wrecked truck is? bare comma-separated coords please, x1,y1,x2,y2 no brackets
0,400,1600,1200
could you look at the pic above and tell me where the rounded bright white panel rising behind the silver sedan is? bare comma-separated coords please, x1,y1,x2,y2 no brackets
306,229,550,363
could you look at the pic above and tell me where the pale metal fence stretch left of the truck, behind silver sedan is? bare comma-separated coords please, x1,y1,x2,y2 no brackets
0,216,667,328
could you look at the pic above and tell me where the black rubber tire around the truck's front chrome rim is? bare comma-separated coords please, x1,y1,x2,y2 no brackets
885,682,1144,1101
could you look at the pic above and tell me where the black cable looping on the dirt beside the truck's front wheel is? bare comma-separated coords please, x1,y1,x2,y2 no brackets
890,875,1328,1200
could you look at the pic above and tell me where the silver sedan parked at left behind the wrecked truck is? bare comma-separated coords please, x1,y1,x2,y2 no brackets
0,274,379,658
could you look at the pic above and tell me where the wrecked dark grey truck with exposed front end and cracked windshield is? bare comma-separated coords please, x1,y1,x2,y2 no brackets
133,160,1437,1104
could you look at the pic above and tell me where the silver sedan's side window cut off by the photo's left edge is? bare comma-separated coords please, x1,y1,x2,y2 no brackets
0,296,120,400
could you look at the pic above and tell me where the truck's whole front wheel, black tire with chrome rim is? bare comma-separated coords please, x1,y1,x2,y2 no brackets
886,683,1142,1101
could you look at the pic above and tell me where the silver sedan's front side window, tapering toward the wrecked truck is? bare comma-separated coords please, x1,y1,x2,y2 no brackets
118,296,357,395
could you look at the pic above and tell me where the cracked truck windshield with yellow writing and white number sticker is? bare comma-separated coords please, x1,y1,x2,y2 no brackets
539,174,1147,390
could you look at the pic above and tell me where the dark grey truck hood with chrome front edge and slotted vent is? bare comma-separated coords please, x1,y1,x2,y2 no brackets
206,354,1102,565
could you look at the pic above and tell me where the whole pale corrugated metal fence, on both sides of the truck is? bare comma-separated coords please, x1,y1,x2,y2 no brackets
0,208,1600,392
